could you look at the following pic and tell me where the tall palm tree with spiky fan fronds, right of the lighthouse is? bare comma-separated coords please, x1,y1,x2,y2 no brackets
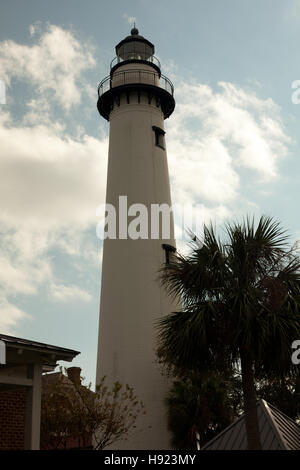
157,216,300,450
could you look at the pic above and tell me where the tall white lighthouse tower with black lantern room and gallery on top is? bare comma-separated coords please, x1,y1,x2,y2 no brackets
97,27,178,449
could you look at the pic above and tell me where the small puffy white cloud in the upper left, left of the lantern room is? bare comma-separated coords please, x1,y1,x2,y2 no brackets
0,24,95,109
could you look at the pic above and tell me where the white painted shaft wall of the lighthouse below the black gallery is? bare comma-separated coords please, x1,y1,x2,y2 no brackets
97,83,178,449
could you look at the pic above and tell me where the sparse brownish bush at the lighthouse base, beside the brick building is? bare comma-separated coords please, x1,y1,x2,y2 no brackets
41,372,144,450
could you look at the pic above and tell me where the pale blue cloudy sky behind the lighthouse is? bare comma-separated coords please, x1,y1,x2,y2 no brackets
0,0,300,383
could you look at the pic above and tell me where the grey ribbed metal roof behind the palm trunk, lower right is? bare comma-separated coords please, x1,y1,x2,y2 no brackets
202,400,300,450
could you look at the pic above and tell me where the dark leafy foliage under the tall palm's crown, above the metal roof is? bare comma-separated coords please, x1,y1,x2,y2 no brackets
166,372,300,450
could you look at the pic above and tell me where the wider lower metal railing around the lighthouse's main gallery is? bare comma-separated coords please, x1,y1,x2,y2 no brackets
98,70,174,97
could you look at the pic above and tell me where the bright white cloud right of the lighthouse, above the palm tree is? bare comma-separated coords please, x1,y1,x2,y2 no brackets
167,82,290,211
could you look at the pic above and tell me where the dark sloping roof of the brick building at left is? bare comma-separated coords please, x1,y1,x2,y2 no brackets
0,333,80,361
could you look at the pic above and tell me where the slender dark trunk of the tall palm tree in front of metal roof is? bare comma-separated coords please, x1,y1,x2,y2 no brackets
240,348,261,450
